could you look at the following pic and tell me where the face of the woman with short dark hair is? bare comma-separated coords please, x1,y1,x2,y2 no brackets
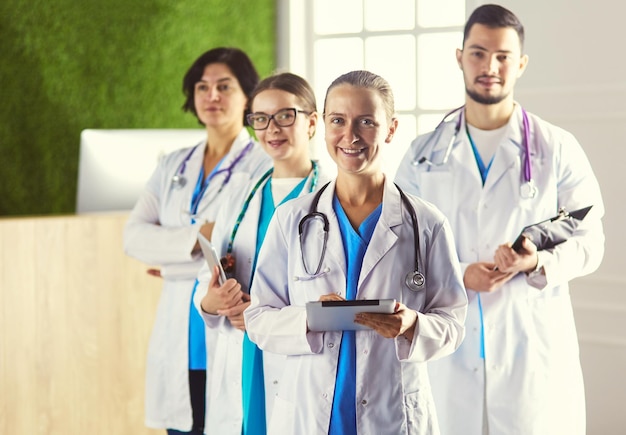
194,63,248,129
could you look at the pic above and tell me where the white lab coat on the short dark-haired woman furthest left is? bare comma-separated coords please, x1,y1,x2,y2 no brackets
124,129,271,431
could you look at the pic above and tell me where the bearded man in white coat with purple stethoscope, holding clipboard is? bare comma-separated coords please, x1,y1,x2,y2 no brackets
396,5,604,435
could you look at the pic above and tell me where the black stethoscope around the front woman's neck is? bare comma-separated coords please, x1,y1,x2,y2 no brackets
295,182,426,291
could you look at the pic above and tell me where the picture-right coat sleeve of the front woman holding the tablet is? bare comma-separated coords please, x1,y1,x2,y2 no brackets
396,220,467,362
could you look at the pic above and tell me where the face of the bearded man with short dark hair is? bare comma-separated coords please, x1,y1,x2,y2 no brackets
456,24,528,104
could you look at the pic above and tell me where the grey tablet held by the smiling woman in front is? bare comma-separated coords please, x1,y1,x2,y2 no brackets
306,299,396,331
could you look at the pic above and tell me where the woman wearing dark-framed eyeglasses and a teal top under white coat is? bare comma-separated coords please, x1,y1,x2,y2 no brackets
194,73,329,435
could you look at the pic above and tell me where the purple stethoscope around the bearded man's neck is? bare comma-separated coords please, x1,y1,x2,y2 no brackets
411,105,537,198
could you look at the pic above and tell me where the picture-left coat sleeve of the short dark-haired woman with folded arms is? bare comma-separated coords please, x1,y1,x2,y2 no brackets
124,158,204,266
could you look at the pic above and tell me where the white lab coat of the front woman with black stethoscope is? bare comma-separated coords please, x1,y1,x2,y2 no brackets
244,178,467,434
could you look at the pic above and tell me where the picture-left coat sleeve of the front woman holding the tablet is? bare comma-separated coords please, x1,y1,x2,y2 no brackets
244,211,323,355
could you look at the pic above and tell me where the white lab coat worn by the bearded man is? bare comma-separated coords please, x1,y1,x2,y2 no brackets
396,105,604,435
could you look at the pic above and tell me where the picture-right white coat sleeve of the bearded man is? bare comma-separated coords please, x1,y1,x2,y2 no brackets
526,131,605,289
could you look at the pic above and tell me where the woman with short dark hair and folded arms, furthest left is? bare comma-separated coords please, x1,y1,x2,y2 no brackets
124,48,269,434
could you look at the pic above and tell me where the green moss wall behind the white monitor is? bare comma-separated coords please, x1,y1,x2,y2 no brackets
0,0,275,216
